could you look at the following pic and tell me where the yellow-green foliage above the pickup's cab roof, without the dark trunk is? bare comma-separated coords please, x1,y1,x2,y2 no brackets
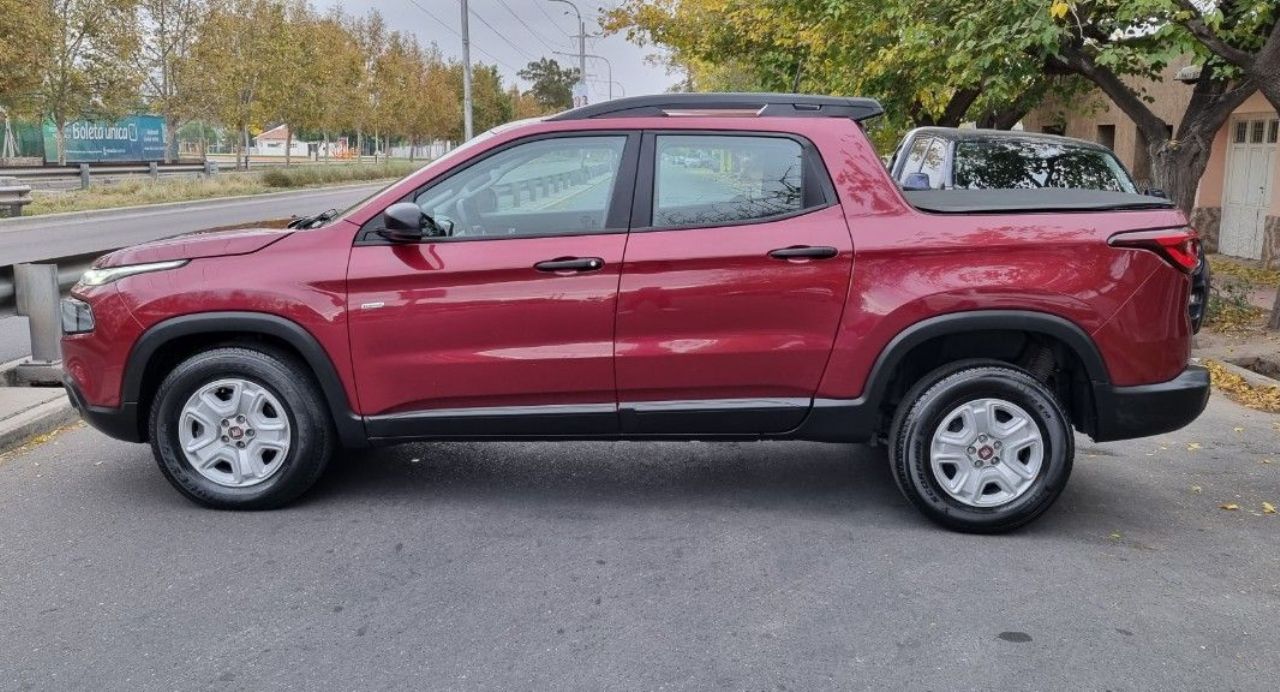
604,0,1047,133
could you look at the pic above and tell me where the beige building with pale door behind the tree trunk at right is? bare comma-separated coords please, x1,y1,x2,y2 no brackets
1023,64,1280,262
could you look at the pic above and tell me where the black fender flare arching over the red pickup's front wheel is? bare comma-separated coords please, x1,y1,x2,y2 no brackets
120,312,369,448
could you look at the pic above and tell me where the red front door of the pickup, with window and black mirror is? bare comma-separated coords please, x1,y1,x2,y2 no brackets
347,133,640,437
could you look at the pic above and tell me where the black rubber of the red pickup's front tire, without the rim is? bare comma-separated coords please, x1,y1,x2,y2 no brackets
150,348,333,509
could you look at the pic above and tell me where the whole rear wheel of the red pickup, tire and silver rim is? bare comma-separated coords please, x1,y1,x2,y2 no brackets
890,361,1075,533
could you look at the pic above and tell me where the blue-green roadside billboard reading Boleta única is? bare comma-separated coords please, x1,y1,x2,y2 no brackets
45,115,165,164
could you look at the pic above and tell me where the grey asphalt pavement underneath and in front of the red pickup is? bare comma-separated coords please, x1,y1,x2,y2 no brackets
0,397,1280,691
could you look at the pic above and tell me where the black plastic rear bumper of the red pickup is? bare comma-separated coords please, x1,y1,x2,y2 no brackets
1093,366,1210,443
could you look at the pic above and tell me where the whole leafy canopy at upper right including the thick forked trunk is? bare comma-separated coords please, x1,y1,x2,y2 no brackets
605,0,1280,211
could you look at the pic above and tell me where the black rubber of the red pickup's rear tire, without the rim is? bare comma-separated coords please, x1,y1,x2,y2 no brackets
891,362,1075,533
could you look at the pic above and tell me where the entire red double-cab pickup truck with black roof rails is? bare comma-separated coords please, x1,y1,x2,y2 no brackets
63,93,1208,532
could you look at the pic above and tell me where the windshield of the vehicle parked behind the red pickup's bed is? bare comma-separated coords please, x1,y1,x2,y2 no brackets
952,139,1137,192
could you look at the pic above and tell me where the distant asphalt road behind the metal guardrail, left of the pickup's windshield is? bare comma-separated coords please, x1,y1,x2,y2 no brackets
0,182,387,266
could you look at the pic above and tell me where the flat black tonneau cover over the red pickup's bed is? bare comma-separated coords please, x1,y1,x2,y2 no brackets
902,188,1174,214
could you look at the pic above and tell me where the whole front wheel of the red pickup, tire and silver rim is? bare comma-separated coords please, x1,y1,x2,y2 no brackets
148,347,335,509
